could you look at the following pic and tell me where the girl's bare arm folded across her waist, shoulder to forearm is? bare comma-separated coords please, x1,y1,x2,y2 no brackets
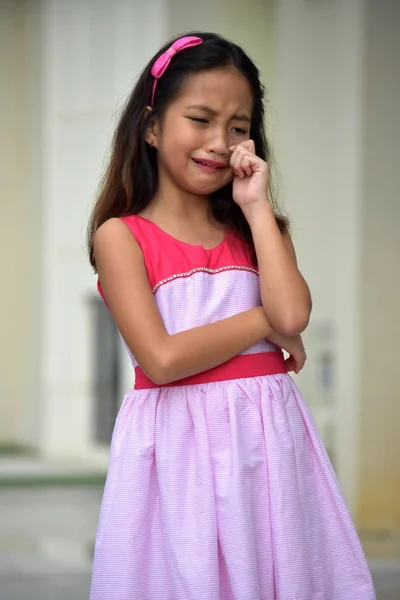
94,219,272,384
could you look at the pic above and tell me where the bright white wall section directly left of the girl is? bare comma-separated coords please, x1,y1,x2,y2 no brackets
41,0,166,456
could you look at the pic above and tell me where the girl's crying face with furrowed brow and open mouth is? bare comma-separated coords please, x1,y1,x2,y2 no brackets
148,68,253,195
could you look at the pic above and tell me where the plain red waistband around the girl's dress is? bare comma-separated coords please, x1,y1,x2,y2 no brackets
135,350,286,390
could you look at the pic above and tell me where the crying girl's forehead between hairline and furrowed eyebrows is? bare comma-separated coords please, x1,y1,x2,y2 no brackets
176,68,253,116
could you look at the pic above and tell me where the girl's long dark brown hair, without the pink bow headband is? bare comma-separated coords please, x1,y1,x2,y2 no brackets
88,32,288,269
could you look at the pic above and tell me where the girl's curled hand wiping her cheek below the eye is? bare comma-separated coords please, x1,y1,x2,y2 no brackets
229,140,268,208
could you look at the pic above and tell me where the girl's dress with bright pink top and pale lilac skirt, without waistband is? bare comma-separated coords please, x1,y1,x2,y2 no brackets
90,215,376,600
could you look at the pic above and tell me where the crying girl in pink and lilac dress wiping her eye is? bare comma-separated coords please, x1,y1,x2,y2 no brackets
89,33,375,600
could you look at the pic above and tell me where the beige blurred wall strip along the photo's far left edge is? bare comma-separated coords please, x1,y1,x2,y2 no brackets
0,0,41,445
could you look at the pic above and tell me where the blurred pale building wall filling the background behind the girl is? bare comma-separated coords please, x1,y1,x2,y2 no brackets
0,0,400,592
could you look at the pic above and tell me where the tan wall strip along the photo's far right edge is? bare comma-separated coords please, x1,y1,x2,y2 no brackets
360,0,400,530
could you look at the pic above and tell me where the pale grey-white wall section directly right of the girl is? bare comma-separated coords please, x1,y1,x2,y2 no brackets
274,0,364,509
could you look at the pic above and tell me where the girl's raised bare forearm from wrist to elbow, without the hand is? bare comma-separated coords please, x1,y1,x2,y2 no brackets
244,201,311,336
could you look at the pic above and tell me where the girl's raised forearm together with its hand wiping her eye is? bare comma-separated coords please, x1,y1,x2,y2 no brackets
230,140,311,337
